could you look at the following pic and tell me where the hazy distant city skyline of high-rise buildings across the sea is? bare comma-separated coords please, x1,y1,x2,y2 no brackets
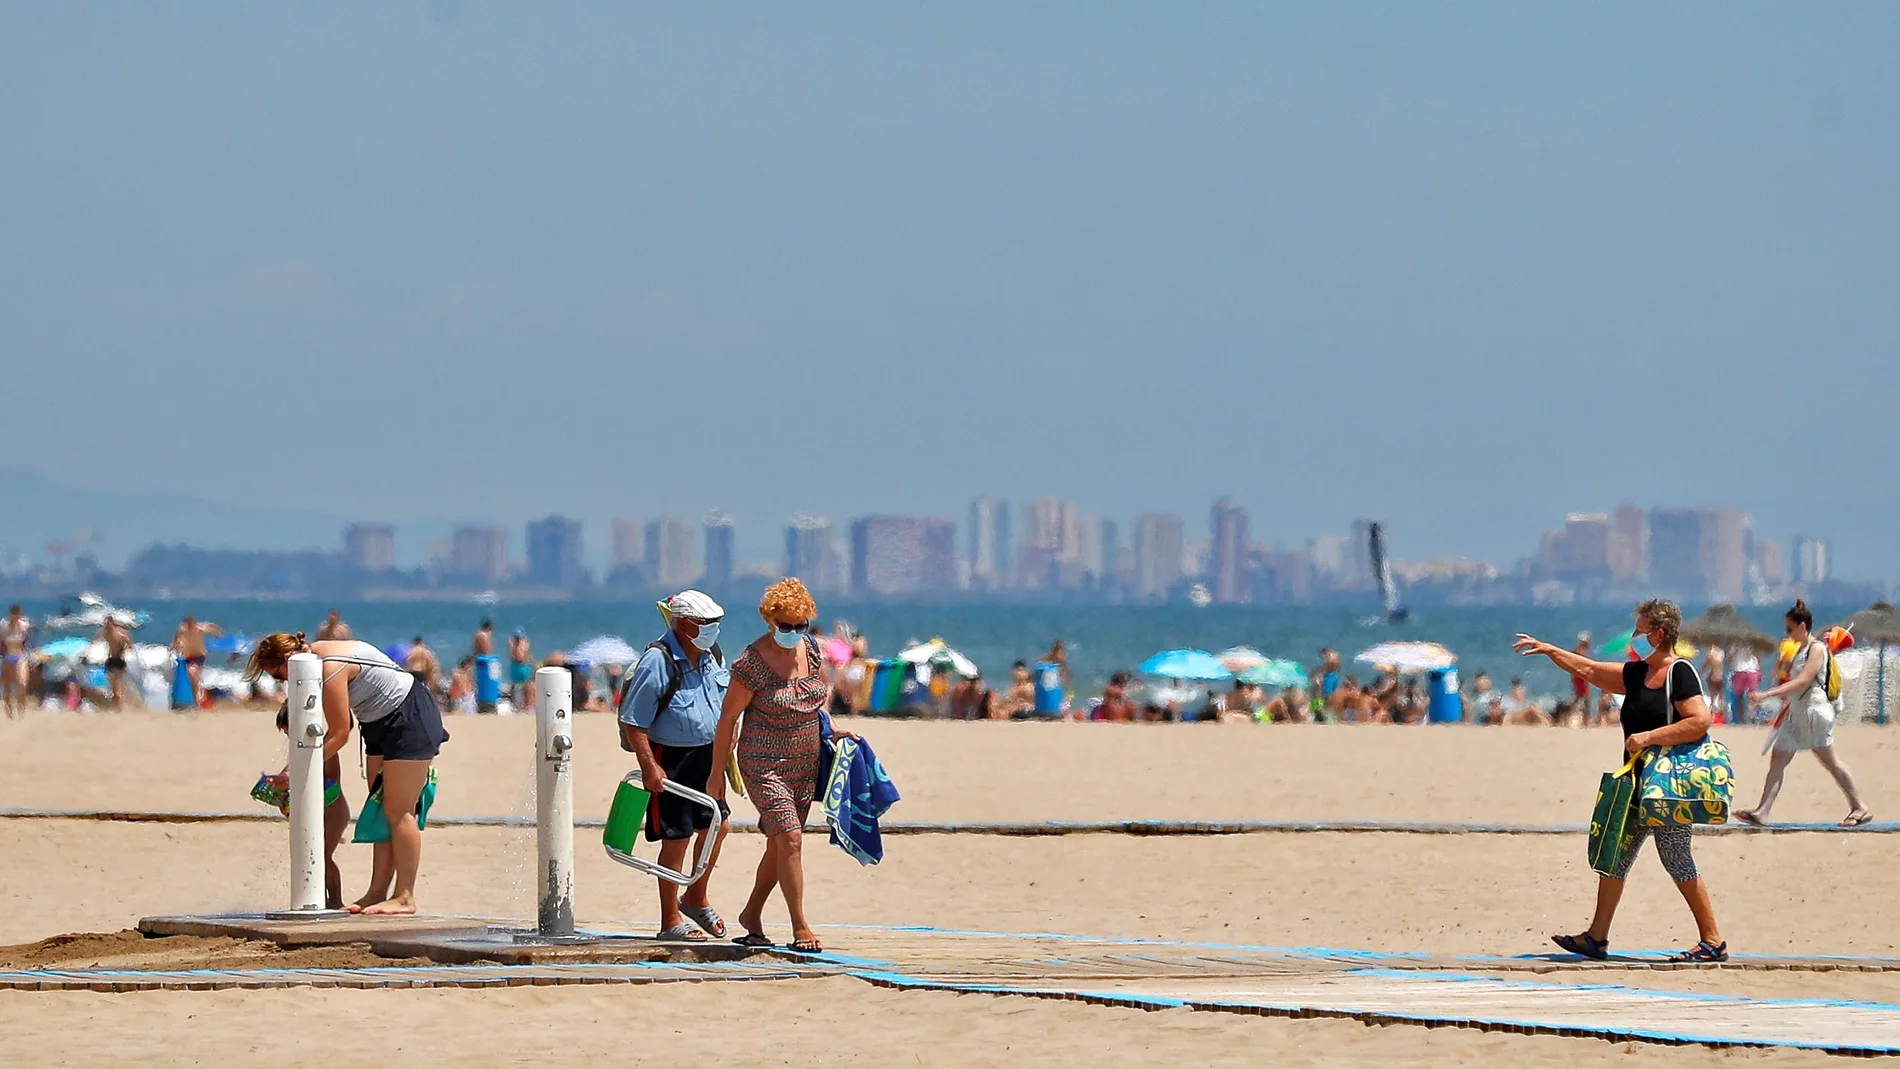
0,494,1885,604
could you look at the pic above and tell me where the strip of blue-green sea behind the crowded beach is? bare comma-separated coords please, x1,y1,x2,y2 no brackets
3,600,1839,697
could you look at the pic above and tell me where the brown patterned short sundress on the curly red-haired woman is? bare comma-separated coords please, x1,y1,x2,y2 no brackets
732,638,827,837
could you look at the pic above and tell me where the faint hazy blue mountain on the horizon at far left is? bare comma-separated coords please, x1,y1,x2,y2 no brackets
0,469,344,568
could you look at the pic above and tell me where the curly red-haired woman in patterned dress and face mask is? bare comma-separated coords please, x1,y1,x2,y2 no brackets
707,579,849,953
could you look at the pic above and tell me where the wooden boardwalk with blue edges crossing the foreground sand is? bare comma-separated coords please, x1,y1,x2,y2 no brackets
14,917,1900,1054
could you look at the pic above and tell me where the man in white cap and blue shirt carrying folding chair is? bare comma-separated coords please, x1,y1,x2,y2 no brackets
619,591,732,942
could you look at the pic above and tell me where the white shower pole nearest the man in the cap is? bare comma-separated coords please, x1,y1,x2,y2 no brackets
534,668,574,938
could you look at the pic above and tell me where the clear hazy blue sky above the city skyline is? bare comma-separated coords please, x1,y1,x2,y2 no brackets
0,0,1900,577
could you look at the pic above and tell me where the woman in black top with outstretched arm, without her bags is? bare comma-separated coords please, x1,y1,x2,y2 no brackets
1516,598,1729,963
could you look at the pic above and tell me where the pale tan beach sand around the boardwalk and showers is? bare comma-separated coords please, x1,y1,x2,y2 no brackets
0,714,1900,1065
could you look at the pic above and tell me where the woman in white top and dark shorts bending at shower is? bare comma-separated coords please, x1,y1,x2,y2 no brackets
247,630,448,913
